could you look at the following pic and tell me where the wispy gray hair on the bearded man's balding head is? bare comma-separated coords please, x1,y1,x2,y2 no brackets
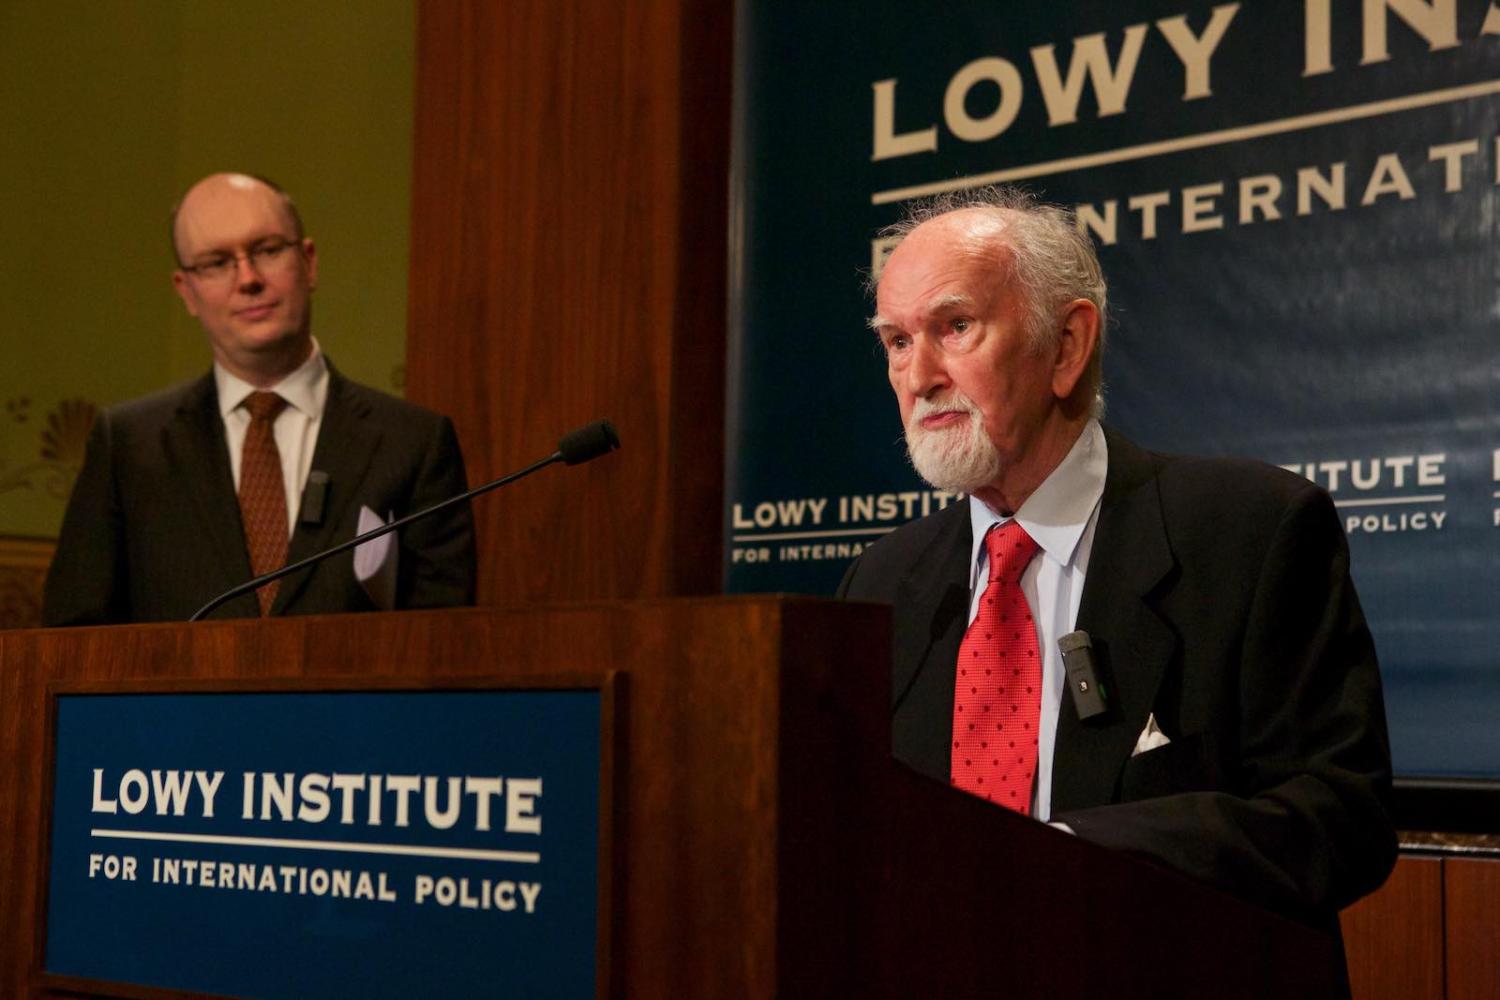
870,184,1109,417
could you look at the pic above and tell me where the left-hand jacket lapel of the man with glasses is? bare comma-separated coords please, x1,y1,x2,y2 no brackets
162,373,260,613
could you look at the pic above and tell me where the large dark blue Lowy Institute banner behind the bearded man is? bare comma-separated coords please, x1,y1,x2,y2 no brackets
725,0,1500,778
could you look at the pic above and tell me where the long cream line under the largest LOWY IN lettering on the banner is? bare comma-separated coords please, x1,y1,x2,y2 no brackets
870,79,1500,205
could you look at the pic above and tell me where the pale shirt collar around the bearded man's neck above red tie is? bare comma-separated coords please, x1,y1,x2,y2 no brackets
969,420,1109,586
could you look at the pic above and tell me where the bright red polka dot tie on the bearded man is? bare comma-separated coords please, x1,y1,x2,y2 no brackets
953,520,1041,816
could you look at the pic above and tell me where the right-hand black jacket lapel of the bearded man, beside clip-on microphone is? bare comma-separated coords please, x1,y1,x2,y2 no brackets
1052,432,1178,814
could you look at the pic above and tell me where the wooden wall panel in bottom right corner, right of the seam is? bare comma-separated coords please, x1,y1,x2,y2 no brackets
1443,858,1500,1000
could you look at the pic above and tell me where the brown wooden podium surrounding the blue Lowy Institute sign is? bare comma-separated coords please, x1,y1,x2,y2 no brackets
0,597,1343,999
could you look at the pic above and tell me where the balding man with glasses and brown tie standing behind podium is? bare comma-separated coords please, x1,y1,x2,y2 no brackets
44,174,474,625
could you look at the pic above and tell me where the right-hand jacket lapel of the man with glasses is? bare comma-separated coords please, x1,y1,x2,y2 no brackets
272,363,390,615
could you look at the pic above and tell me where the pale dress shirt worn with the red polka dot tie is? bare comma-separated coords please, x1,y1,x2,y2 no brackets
969,420,1109,822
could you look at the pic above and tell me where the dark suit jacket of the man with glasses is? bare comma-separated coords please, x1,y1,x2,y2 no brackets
44,366,474,625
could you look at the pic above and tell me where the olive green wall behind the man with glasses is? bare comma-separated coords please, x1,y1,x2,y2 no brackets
0,0,416,537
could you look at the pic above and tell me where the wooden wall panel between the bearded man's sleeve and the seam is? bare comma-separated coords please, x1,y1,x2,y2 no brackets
1343,856,1443,1000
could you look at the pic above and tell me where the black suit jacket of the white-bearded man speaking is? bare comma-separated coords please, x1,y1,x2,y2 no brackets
840,432,1395,925
